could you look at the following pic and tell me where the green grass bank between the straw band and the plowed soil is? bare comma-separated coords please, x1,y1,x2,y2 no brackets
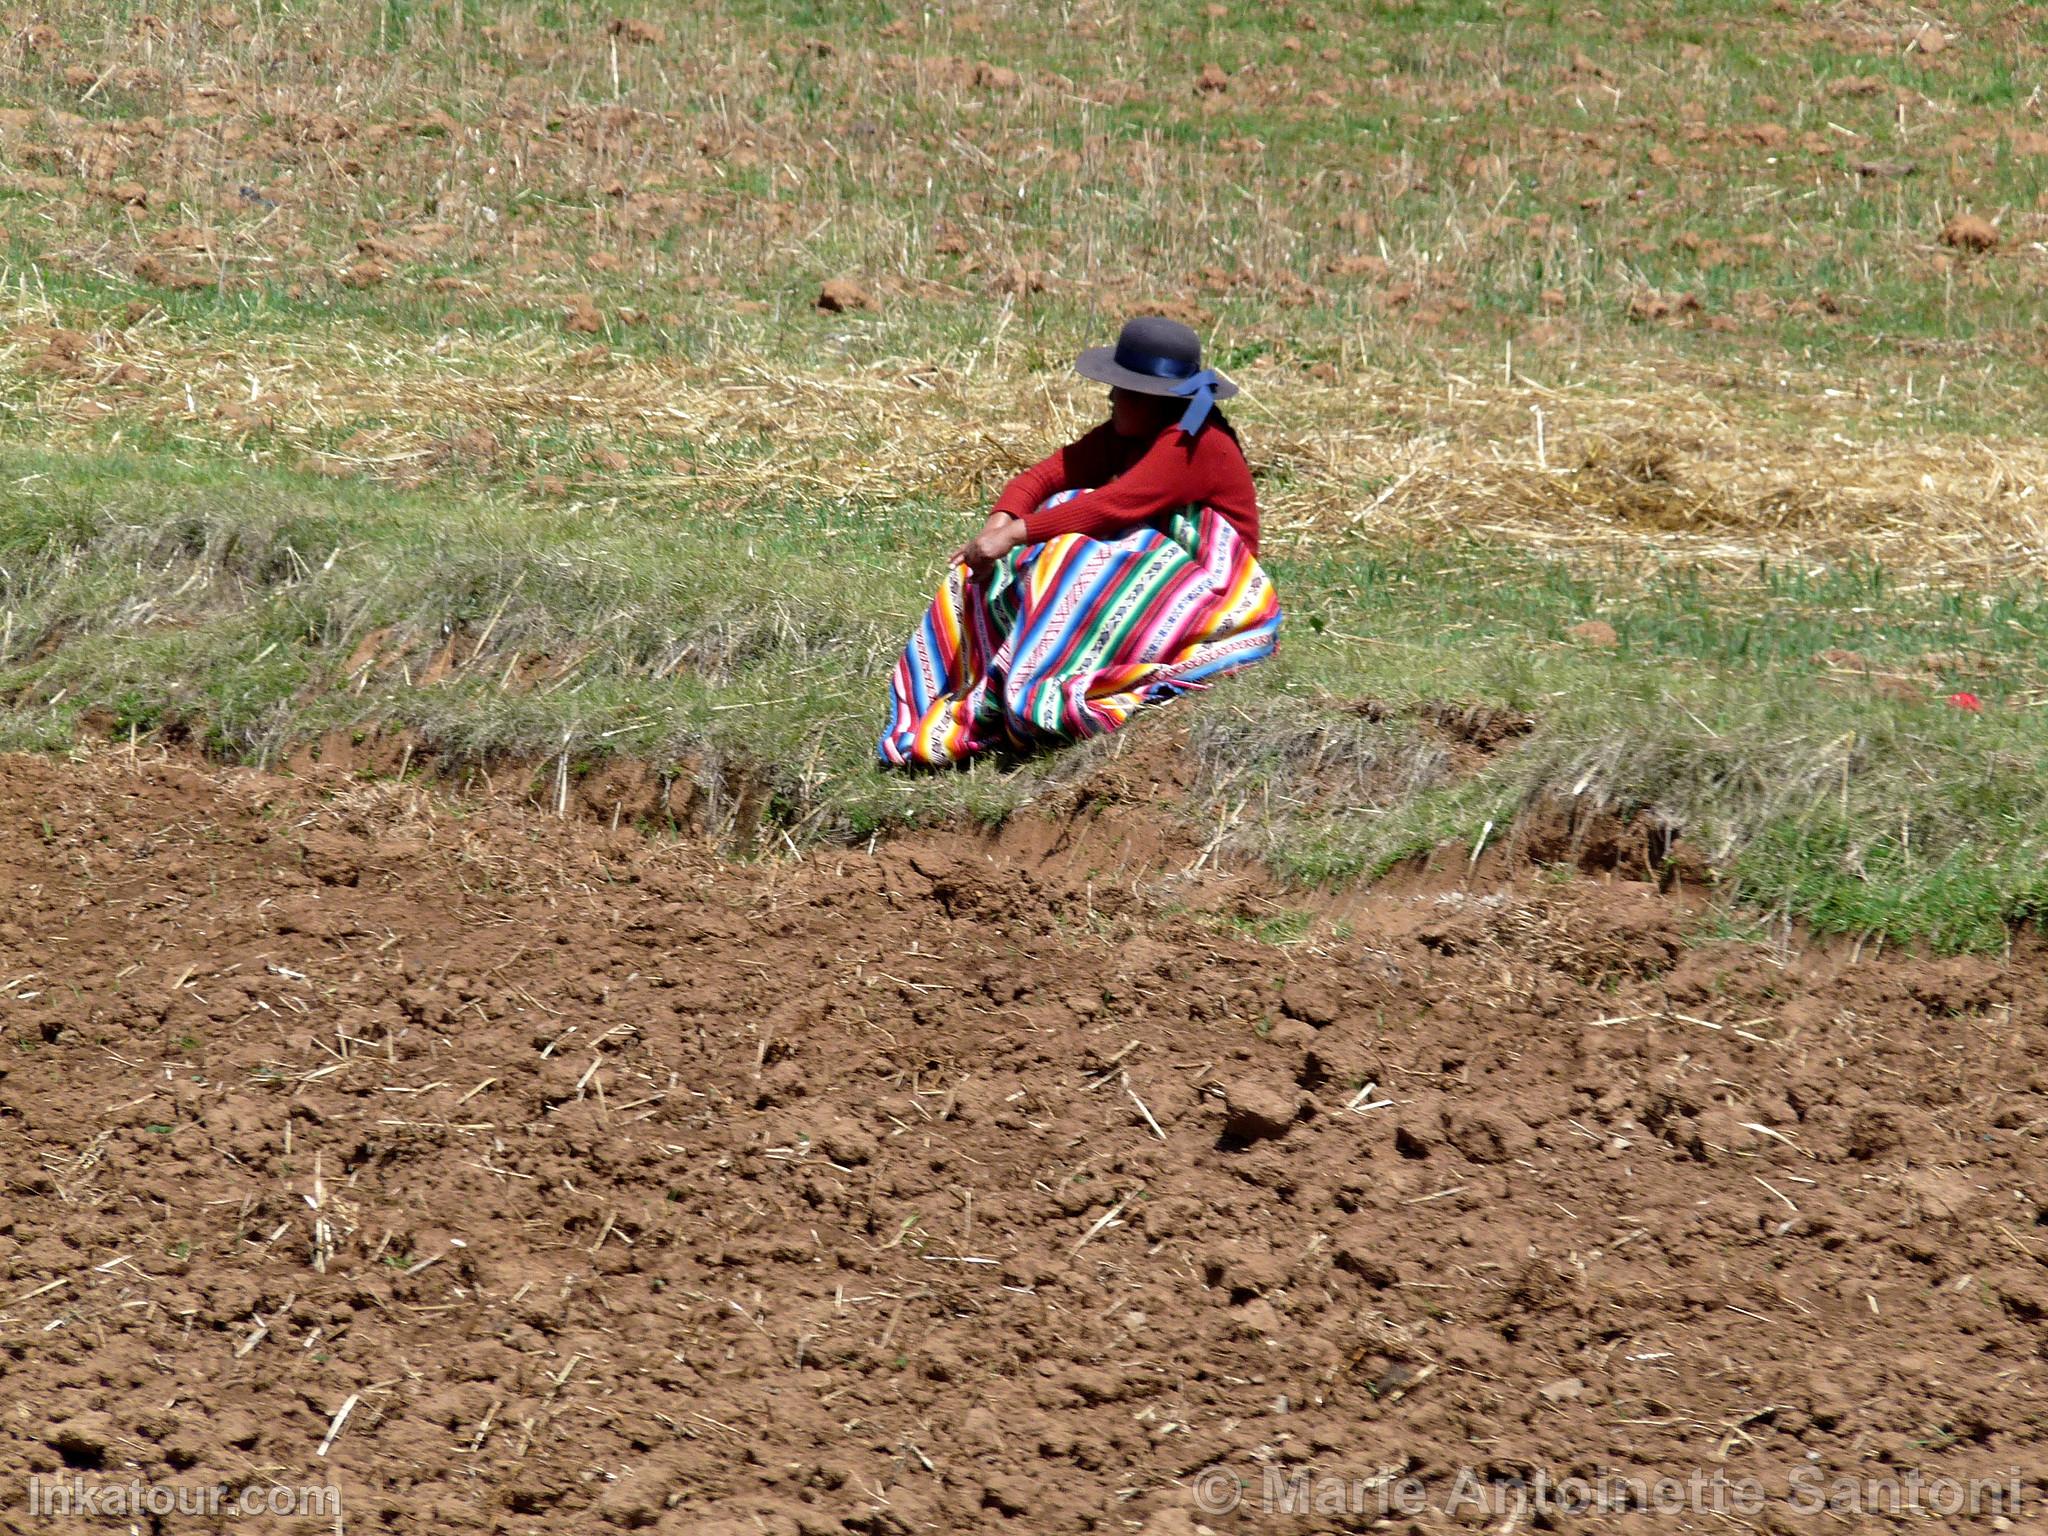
0,436,2048,948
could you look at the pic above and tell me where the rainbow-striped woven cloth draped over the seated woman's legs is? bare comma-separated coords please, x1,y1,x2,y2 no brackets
879,492,1280,766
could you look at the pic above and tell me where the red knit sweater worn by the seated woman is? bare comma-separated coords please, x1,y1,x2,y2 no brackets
995,412,1260,555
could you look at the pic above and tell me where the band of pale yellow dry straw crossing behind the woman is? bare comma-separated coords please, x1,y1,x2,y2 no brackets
16,299,2048,582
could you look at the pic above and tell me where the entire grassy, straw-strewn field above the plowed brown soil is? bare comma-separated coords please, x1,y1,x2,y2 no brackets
0,0,2048,946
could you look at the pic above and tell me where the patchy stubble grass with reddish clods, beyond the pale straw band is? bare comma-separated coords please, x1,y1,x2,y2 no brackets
0,0,2048,420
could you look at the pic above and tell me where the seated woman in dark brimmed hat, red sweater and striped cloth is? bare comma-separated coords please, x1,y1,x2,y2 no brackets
879,317,1280,766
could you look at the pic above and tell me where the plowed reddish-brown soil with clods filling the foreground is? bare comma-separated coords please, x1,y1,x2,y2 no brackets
0,754,2048,1536
